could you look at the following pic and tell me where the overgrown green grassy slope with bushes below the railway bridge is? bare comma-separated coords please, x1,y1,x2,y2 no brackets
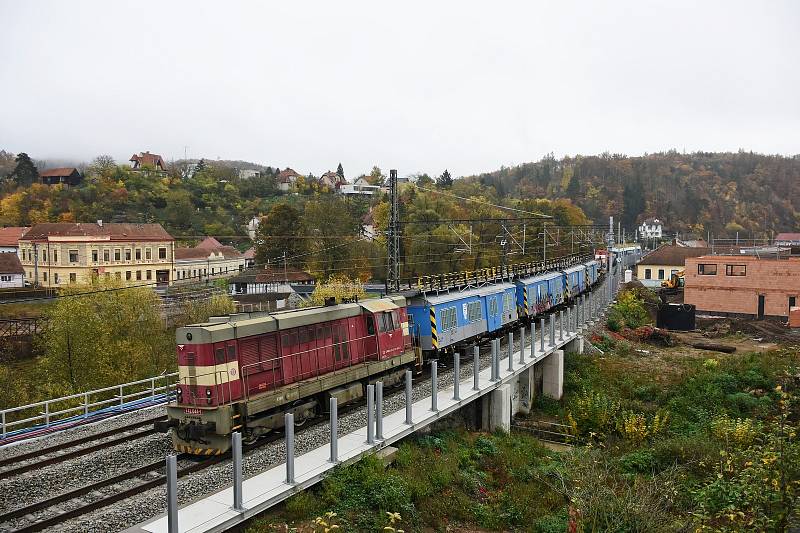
251,328,800,532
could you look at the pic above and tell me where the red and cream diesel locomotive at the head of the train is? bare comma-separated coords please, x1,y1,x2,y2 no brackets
157,296,417,455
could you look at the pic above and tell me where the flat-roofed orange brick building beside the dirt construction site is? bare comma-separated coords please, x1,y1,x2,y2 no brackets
683,255,800,318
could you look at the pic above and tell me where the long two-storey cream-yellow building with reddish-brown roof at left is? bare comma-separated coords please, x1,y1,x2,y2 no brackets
19,220,175,287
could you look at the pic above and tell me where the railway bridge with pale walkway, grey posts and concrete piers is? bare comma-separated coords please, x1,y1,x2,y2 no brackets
128,276,619,533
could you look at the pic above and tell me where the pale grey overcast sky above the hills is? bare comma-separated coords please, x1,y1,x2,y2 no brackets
0,0,800,175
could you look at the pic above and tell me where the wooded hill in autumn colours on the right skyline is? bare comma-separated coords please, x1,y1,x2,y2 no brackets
467,151,800,237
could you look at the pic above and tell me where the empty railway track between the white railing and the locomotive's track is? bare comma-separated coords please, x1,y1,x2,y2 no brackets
0,416,166,480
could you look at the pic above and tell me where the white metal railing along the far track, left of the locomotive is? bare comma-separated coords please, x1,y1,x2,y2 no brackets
0,372,178,439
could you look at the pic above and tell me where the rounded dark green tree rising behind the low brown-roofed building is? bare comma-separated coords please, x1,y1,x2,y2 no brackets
255,203,306,266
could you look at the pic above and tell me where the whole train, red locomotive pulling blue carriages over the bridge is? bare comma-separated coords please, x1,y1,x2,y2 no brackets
157,255,603,455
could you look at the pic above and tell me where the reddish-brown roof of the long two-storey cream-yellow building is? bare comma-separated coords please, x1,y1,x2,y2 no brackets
20,222,175,241
